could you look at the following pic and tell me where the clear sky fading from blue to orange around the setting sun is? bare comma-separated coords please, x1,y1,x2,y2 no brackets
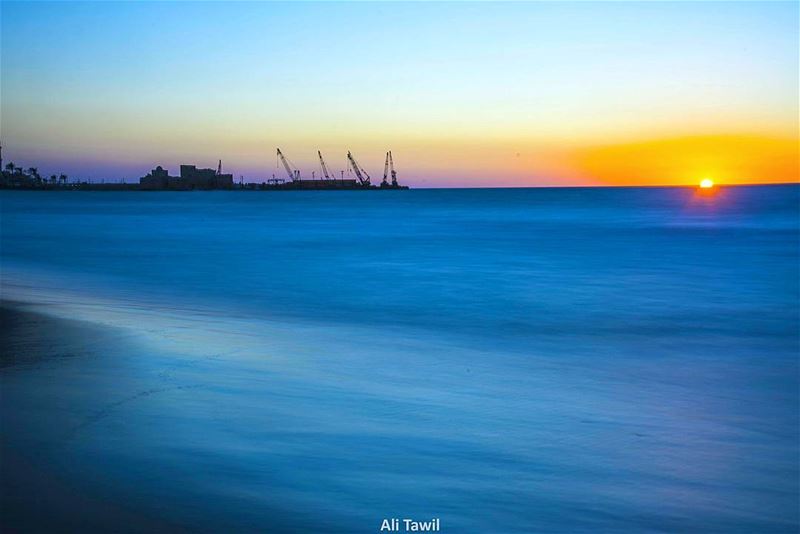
0,1,800,187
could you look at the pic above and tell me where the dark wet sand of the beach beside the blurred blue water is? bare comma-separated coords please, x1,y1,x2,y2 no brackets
0,301,311,533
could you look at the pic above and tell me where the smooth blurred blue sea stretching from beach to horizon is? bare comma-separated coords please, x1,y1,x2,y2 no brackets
0,185,800,533
